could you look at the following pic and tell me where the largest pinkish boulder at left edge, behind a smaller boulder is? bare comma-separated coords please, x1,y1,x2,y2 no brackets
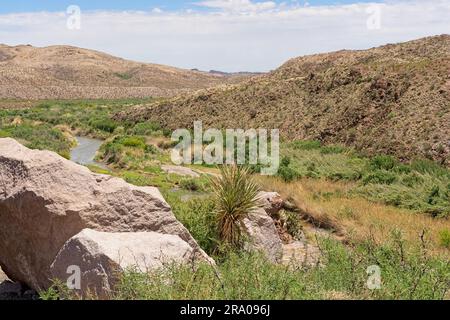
0,139,211,290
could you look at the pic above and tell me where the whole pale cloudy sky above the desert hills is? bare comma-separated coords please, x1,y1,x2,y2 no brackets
0,0,450,71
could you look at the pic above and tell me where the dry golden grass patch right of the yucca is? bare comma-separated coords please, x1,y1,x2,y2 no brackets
258,177,450,256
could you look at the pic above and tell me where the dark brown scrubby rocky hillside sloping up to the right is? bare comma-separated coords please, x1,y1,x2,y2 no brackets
117,35,450,165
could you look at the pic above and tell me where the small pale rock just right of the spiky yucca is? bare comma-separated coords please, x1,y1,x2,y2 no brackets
243,192,283,263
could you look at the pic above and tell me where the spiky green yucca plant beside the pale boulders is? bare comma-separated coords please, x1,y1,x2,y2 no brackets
212,165,259,248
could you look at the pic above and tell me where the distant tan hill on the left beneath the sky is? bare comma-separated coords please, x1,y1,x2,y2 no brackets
0,45,239,99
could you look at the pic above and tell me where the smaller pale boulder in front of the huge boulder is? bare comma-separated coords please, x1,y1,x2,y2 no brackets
50,229,195,299
